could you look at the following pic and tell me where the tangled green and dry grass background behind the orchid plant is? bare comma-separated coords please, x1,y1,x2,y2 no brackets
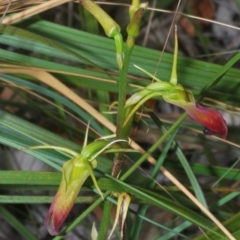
0,0,240,239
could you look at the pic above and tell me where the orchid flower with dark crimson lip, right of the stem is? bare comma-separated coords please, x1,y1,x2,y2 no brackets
124,25,228,138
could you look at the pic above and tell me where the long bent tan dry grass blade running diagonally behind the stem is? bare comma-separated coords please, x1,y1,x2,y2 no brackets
1,68,236,240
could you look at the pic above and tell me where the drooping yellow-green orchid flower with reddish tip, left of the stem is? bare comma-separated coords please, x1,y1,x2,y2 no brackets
43,124,129,236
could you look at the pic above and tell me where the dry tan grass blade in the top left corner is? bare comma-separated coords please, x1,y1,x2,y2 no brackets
2,0,71,24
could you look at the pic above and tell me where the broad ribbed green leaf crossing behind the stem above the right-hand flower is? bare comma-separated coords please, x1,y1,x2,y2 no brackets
13,21,240,101
